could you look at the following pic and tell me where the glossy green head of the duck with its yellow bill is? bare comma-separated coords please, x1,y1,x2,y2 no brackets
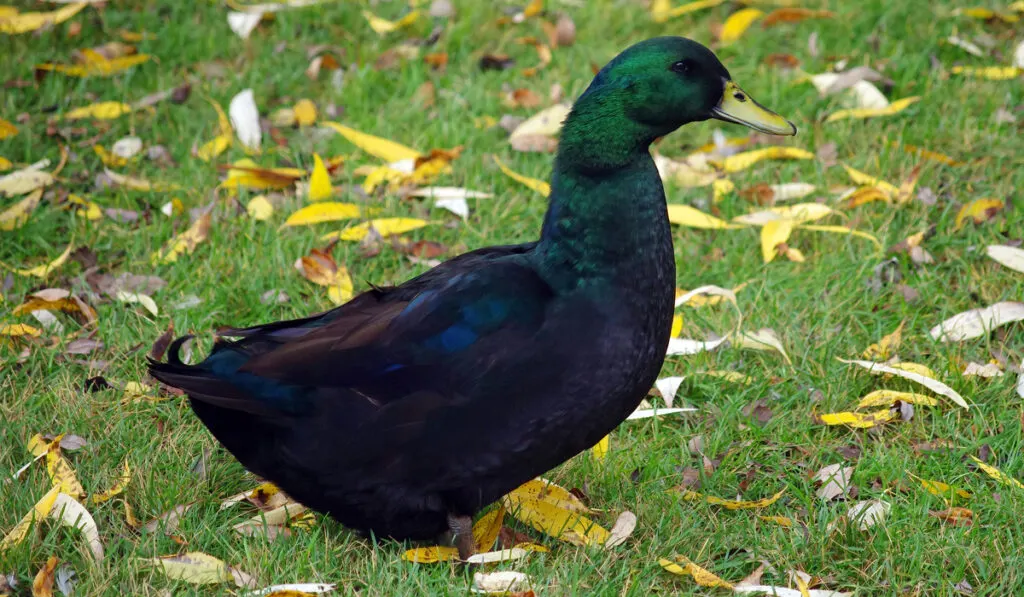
581,37,797,136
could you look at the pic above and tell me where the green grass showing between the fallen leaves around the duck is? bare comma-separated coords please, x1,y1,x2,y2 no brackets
0,0,1024,595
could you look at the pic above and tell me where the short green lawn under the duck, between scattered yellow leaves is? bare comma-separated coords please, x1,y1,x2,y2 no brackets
0,0,1024,595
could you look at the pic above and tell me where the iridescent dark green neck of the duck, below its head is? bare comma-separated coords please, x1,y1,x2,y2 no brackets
538,94,675,288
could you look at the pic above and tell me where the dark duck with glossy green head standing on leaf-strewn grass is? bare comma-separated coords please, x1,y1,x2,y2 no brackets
148,37,797,559
